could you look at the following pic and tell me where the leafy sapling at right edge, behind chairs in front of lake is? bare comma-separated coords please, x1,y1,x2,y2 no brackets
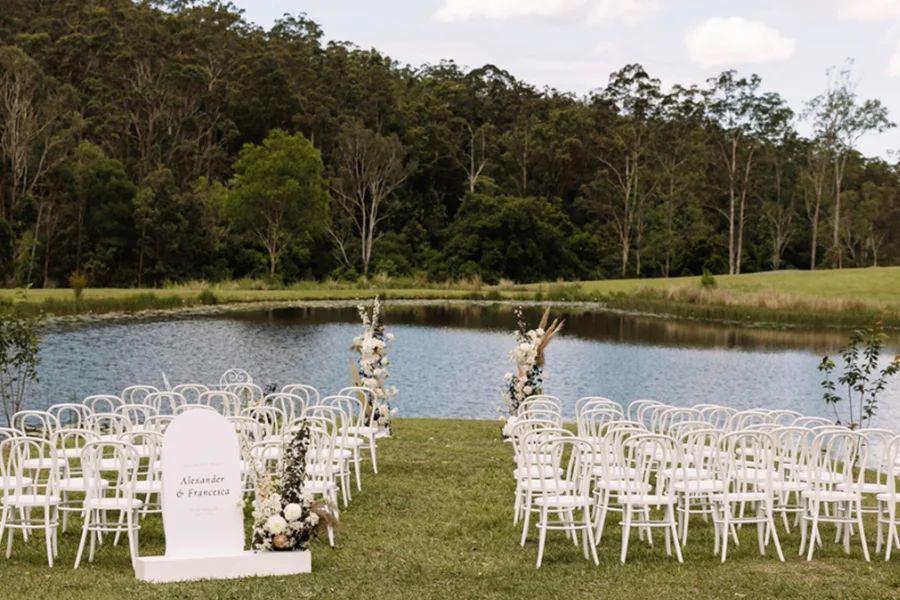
819,322,900,429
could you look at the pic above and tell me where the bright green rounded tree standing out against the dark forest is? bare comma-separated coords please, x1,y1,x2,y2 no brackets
228,129,328,278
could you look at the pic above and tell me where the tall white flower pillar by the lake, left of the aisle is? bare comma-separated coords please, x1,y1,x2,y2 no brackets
350,297,397,434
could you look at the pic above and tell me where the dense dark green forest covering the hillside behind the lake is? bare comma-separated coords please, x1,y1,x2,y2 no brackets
0,0,900,287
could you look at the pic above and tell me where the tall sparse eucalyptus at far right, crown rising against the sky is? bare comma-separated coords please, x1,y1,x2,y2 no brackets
805,60,894,268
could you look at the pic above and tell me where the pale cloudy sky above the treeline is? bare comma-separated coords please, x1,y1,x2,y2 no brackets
233,0,900,157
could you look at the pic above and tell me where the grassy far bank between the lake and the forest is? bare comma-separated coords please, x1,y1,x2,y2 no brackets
0,267,900,328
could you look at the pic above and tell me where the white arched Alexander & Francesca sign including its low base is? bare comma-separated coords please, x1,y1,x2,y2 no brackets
134,409,311,582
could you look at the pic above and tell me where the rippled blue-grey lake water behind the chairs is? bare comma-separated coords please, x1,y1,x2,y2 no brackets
28,302,900,430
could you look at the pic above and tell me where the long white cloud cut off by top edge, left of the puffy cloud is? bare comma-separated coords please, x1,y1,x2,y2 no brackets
434,0,660,23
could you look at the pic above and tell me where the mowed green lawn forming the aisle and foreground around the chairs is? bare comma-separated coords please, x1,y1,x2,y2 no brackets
0,419,900,600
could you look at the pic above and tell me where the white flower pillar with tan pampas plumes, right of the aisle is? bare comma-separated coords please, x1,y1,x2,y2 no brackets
505,307,565,426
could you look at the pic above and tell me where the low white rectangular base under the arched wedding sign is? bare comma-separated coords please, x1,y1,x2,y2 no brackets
134,550,312,583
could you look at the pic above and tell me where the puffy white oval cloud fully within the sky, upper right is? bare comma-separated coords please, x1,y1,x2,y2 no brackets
685,17,797,67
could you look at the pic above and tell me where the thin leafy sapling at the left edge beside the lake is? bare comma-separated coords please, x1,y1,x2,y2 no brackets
0,308,41,425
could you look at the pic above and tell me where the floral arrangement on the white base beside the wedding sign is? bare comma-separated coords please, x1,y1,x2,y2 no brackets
244,426,338,551
